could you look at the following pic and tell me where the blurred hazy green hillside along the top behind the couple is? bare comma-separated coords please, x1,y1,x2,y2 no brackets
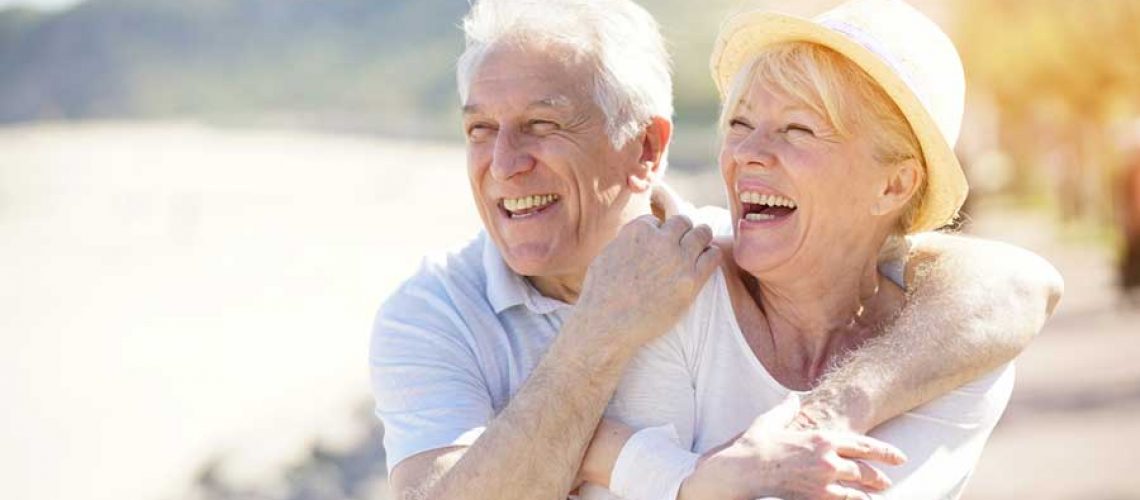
0,0,916,166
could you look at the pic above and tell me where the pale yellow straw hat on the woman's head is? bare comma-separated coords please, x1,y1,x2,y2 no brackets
710,0,969,232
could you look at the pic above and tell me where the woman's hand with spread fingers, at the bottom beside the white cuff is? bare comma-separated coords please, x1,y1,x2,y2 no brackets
678,397,906,500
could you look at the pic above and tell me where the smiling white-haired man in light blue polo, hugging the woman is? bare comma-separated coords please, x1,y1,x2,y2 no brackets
371,0,1060,499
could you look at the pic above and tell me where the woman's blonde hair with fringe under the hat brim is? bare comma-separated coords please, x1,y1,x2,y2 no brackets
719,42,927,233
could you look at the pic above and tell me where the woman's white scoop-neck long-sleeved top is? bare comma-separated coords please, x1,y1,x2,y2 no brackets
581,265,1013,499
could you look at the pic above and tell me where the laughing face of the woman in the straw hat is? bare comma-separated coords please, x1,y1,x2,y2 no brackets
720,82,889,278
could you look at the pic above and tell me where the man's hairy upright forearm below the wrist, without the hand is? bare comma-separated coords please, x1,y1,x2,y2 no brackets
425,320,629,499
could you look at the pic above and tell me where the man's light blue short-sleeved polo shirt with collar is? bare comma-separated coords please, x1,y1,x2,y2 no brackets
369,232,572,473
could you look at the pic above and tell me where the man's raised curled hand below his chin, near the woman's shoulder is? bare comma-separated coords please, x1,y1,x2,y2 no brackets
577,215,720,352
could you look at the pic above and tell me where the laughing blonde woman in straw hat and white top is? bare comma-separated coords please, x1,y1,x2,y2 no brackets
583,0,1013,499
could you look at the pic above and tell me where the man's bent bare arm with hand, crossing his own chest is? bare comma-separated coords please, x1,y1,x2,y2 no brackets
390,216,719,499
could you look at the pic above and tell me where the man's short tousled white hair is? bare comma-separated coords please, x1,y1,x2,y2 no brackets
456,0,673,148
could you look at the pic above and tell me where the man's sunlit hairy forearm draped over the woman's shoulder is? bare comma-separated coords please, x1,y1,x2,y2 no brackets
804,235,1062,432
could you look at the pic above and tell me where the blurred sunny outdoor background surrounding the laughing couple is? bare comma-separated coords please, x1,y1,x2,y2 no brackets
0,0,1140,500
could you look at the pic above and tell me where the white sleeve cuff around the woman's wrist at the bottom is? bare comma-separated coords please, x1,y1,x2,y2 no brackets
610,424,700,500
